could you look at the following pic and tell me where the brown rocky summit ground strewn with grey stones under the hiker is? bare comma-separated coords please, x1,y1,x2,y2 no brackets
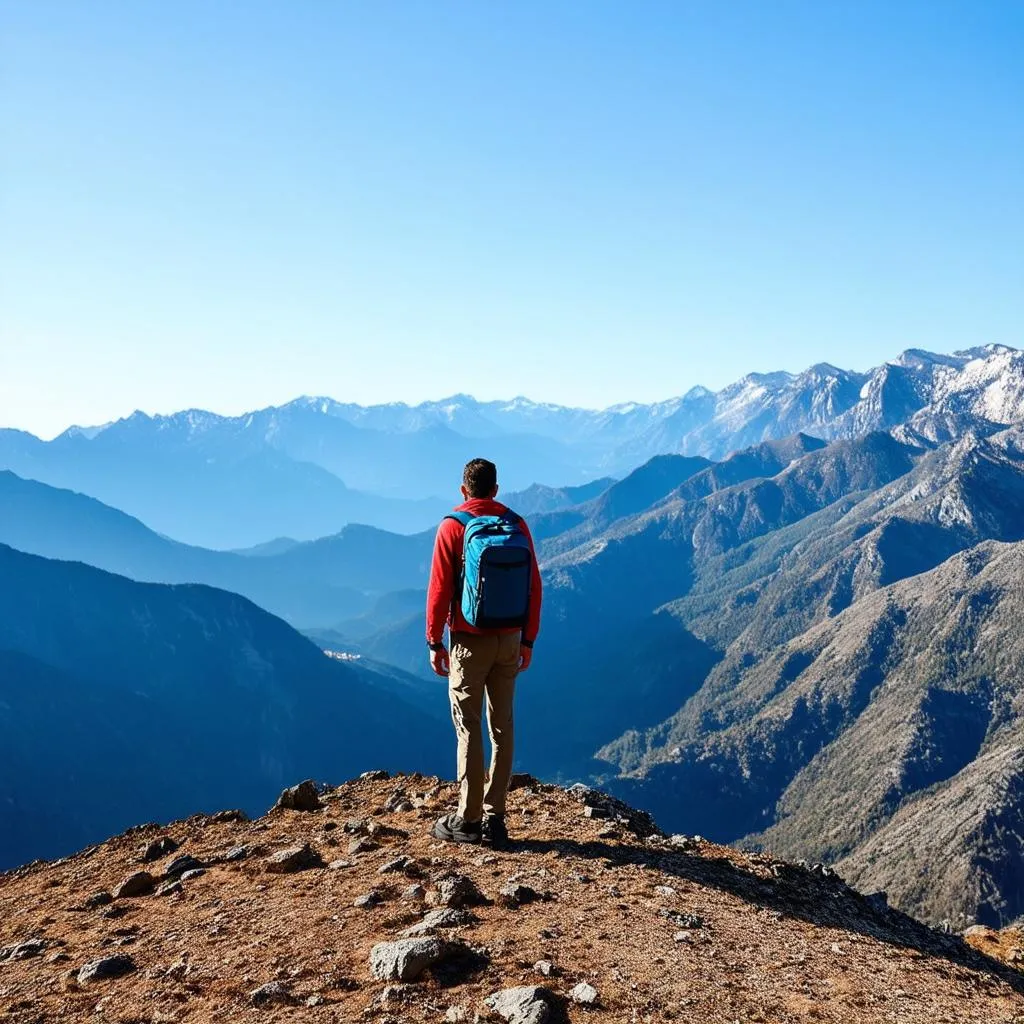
0,773,1024,1024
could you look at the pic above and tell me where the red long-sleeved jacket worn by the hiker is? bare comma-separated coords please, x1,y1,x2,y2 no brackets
427,498,541,644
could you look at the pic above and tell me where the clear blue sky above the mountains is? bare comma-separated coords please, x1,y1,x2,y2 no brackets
0,0,1024,434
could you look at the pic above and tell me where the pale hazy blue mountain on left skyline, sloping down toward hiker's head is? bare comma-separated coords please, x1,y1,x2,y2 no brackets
0,414,446,548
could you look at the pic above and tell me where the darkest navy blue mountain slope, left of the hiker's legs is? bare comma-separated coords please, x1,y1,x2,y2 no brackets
0,546,451,867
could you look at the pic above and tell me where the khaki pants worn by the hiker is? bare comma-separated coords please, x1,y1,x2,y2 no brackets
449,632,521,821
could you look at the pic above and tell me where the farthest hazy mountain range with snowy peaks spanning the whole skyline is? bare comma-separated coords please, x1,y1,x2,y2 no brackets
0,346,1024,549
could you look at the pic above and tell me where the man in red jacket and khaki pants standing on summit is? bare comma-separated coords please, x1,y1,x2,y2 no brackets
427,459,541,847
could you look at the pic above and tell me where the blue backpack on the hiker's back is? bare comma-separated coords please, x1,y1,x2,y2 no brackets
444,512,534,630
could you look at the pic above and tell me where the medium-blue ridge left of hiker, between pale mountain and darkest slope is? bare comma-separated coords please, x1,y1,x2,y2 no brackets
0,471,433,628
